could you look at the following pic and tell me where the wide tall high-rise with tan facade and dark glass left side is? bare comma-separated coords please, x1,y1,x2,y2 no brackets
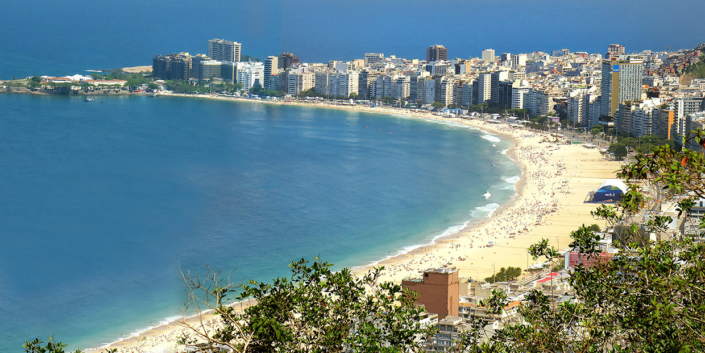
600,57,644,117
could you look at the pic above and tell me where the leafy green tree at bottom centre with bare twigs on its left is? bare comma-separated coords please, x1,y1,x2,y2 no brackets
176,258,435,353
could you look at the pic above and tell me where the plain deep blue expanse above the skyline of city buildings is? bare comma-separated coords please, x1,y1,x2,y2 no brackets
0,0,705,78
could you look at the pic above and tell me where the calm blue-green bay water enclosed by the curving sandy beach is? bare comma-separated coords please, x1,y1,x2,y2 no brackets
0,95,520,353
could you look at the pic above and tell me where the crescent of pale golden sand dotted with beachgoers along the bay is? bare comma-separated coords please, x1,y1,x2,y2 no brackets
88,95,620,353
